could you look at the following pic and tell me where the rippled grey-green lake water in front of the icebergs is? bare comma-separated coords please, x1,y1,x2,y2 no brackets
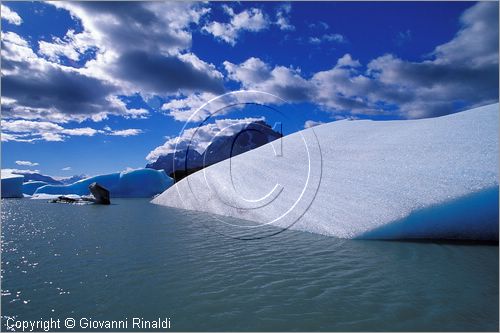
1,199,499,331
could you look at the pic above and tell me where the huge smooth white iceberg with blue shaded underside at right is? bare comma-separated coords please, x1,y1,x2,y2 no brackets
152,104,499,239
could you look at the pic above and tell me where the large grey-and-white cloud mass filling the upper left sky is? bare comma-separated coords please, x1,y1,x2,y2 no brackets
2,1,224,127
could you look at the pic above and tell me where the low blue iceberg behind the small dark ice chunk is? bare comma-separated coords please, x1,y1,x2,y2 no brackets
34,169,174,198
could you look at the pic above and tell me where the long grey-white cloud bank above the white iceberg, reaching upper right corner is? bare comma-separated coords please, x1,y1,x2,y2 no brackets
224,2,498,119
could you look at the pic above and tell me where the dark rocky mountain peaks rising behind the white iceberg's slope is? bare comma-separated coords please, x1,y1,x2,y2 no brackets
146,121,282,181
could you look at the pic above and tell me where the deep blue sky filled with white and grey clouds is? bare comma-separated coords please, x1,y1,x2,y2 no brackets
1,1,499,177
